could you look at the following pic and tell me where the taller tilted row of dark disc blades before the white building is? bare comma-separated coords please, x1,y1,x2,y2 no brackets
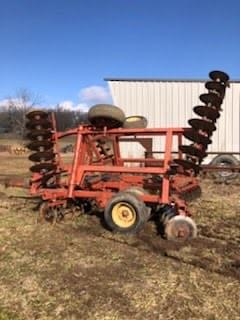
175,71,229,174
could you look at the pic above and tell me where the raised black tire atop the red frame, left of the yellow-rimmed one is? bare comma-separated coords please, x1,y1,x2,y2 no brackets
88,104,125,129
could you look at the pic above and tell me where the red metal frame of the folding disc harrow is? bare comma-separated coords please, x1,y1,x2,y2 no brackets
31,115,198,214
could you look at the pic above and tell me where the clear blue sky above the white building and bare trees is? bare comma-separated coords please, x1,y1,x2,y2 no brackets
0,0,240,109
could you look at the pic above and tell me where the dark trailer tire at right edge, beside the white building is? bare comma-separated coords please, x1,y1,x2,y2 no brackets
210,154,239,182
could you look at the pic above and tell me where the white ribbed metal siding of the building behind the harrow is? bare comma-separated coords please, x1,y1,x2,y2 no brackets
108,80,240,160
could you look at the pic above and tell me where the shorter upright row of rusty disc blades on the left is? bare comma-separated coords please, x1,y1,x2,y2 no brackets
26,110,56,173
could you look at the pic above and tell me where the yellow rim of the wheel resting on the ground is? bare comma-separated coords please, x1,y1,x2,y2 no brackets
112,202,137,228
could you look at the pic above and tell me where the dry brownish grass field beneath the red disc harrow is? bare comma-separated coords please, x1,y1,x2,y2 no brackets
0,154,240,320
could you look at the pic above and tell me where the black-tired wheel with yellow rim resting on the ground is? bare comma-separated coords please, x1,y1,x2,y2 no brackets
104,192,148,234
